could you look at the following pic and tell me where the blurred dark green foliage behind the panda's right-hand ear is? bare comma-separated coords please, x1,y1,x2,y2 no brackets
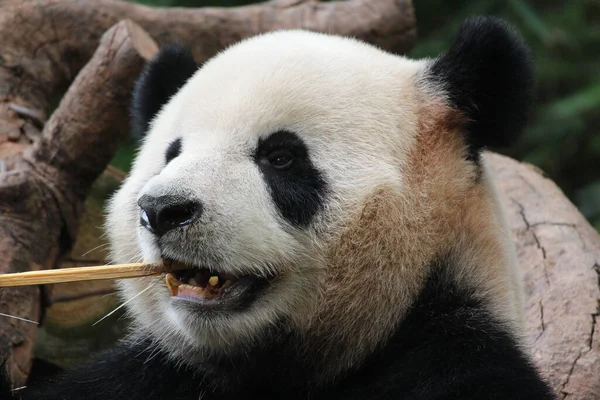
113,0,600,231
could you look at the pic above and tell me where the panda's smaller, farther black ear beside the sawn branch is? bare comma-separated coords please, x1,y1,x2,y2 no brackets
131,44,198,139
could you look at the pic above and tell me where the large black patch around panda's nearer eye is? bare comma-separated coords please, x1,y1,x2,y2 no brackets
253,131,327,227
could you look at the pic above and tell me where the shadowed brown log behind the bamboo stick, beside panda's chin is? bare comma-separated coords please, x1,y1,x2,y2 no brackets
30,166,130,368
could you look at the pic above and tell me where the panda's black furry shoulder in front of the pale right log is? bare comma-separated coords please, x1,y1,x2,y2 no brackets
336,261,553,400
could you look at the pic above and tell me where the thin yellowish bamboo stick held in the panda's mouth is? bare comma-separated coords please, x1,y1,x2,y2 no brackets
0,263,166,287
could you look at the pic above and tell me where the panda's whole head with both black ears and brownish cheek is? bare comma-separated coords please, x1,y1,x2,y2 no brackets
107,18,532,376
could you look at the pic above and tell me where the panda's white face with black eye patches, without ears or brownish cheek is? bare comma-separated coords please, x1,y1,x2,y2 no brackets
108,32,422,356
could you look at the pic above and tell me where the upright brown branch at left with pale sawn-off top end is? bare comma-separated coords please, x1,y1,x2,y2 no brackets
0,21,158,384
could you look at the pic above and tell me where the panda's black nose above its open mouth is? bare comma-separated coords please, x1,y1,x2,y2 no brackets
138,195,202,236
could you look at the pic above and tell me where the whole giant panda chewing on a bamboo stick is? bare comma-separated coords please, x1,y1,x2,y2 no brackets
7,17,554,400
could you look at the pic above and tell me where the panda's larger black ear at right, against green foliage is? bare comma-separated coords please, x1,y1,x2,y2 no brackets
430,17,533,161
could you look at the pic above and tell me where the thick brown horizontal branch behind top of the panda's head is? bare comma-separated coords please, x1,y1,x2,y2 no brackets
0,0,416,155
